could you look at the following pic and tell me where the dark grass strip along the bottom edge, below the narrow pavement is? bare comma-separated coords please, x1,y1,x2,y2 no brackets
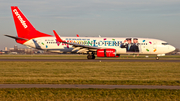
0,88,180,101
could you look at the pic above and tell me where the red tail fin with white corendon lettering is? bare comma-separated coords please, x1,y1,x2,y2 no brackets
11,6,51,43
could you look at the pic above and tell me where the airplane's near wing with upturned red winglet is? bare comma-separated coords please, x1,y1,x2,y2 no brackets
53,30,100,53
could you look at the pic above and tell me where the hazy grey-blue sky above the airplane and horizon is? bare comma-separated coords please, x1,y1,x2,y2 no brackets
0,0,180,50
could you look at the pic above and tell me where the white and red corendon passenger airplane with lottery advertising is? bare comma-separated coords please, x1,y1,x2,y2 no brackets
5,6,175,60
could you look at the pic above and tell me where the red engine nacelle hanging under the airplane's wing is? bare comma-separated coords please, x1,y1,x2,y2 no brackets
97,49,120,57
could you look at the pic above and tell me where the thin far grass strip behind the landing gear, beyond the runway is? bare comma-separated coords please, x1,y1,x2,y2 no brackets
0,54,180,59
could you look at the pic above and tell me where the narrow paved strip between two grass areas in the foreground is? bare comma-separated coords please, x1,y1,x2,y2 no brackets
0,84,180,89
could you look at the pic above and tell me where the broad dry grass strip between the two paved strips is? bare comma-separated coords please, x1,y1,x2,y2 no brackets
0,62,180,85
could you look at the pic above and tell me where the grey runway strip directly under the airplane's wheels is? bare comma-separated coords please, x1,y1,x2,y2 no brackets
0,59,180,62
